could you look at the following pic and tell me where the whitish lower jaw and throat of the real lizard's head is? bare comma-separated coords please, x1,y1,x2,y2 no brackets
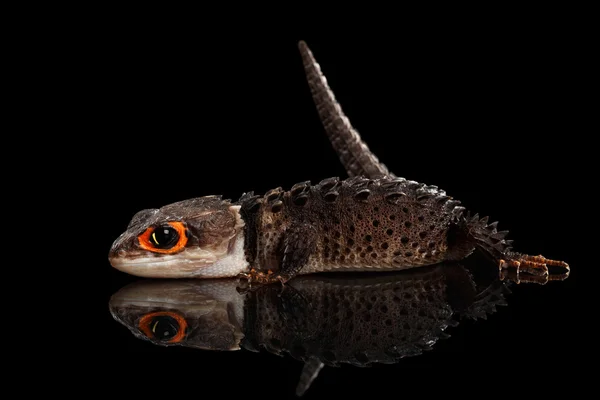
110,235,248,278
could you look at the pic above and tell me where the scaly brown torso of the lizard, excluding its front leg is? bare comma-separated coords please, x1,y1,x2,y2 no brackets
248,178,460,274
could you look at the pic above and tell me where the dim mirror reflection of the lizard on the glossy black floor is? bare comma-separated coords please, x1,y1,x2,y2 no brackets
109,257,568,395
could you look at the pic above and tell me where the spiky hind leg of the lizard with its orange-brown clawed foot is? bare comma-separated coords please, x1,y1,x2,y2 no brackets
465,214,570,279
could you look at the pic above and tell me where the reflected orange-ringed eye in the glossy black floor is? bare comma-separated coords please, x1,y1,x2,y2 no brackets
139,311,187,343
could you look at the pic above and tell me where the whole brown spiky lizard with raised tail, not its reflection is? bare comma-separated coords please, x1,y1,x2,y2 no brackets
109,41,570,284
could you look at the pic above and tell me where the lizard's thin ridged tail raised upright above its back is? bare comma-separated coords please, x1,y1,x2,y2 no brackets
298,41,390,178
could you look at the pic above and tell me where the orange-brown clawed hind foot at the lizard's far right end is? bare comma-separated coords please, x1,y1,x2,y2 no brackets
499,253,570,284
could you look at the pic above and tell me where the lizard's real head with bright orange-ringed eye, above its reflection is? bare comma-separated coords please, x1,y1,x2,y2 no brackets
109,196,244,278
